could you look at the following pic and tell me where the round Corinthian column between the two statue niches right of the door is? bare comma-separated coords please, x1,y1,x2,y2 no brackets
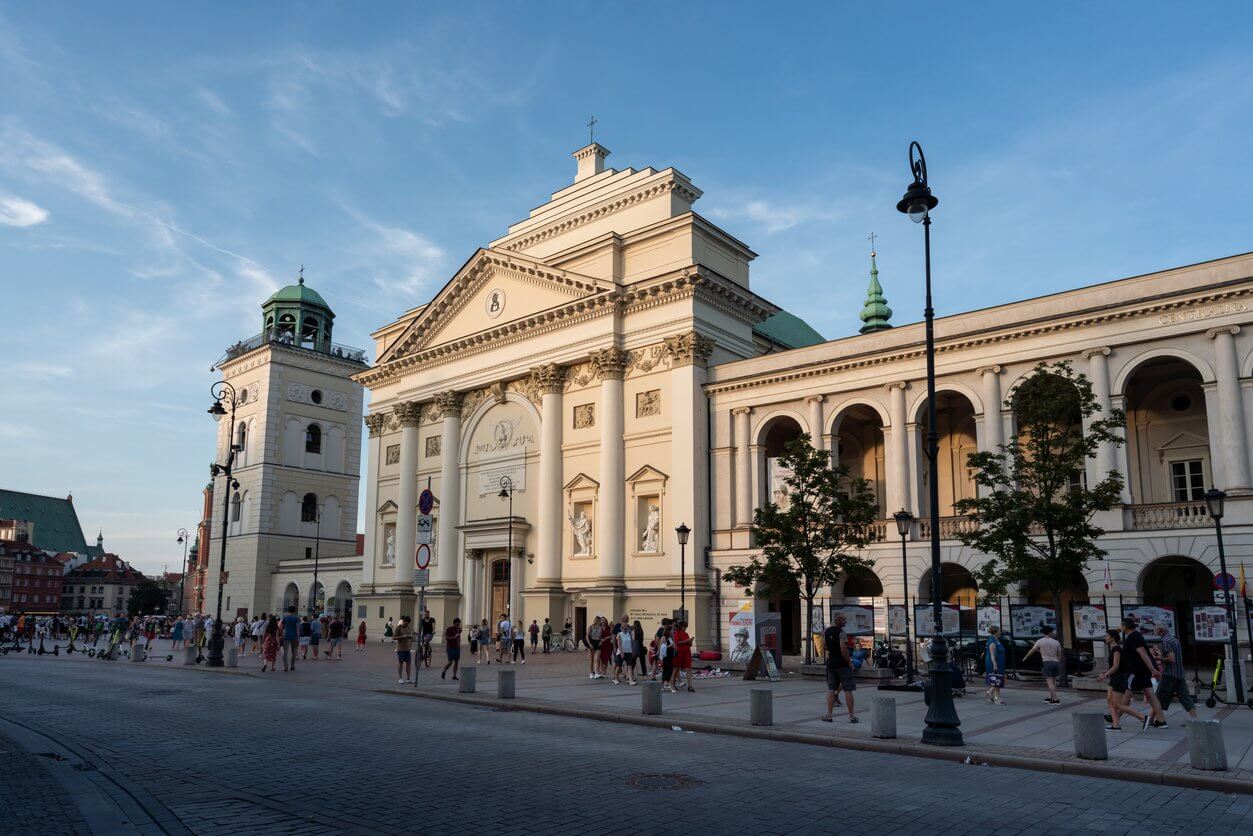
591,348,627,584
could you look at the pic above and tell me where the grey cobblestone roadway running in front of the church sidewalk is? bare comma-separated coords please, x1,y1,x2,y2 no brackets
0,657,1253,833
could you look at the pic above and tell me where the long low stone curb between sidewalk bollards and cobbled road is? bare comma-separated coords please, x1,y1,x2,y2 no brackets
377,688,1253,795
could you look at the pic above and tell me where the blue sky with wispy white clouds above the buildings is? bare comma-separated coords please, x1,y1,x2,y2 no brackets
0,3,1253,572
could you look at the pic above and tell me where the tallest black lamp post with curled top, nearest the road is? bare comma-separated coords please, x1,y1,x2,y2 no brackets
896,142,962,746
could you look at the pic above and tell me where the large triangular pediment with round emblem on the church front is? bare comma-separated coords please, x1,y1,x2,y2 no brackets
377,249,614,365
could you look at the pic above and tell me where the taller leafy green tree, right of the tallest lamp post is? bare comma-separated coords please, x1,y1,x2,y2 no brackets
955,361,1126,681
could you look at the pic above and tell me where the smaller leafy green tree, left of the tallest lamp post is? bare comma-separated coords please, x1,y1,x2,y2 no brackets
725,435,878,663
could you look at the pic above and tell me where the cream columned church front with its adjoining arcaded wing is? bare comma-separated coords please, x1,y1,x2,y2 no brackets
353,143,1253,648
